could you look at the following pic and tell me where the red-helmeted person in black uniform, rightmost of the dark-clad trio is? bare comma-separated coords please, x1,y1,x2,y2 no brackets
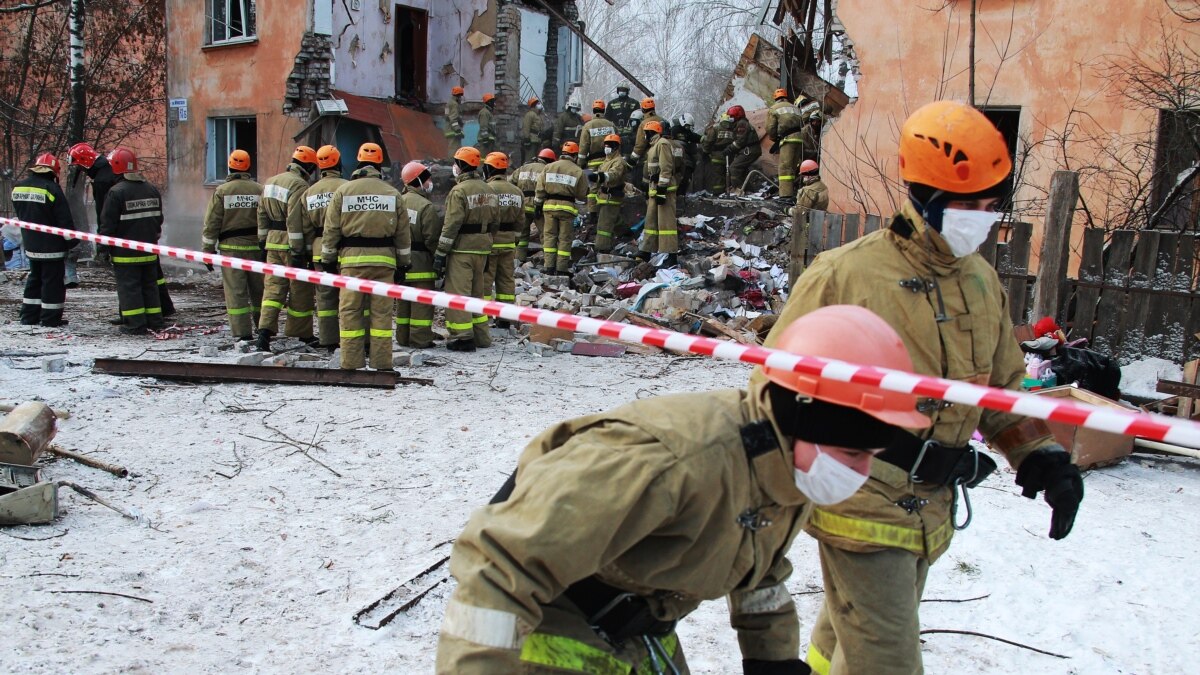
96,148,163,335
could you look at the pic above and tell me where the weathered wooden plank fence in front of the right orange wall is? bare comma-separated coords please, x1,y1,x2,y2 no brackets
790,211,1200,364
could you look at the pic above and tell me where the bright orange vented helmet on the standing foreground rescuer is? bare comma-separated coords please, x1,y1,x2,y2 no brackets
900,101,1013,195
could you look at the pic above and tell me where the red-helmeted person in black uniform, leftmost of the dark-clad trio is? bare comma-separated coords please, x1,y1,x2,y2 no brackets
12,153,79,328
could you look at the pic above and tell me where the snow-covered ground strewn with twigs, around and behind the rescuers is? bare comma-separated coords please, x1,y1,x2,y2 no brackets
0,273,1200,674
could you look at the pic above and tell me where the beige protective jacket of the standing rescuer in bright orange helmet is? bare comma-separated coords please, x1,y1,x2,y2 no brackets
752,201,1054,561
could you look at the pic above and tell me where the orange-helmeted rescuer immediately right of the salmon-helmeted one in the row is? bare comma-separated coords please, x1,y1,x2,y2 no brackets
433,147,497,352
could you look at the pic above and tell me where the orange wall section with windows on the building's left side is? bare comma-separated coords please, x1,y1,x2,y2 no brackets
166,0,308,246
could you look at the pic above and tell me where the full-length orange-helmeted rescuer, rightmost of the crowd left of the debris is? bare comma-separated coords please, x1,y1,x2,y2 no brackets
638,120,679,267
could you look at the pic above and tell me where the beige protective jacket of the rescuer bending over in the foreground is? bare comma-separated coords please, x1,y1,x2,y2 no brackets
437,386,808,675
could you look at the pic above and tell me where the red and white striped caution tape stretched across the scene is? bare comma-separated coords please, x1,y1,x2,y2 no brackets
9,217,1200,448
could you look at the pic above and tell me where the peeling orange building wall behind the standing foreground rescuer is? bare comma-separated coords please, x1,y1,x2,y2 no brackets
822,0,1181,273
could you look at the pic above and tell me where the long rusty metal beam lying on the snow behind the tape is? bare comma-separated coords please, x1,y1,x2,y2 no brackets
91,359,403,389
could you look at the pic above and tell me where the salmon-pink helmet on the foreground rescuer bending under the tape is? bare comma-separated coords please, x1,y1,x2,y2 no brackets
763,305,930,429
